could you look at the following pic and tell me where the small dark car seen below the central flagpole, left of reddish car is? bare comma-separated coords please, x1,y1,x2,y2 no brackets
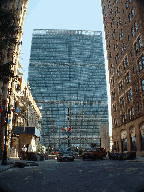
57,151,75,162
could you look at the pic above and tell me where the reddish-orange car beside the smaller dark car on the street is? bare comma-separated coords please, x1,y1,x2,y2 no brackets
82,148,106,161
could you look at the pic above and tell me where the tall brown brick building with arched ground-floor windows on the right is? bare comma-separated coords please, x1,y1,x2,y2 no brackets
101,0,144,155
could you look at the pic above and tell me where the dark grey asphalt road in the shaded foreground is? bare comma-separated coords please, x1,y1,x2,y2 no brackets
0,159,144,192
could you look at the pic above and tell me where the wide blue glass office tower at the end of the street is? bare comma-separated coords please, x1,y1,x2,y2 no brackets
28,30,108,149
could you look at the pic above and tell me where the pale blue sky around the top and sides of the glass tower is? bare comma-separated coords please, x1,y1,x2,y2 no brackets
20,0,112,135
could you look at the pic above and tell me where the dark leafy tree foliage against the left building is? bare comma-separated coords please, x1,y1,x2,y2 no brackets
0,7,20,82
